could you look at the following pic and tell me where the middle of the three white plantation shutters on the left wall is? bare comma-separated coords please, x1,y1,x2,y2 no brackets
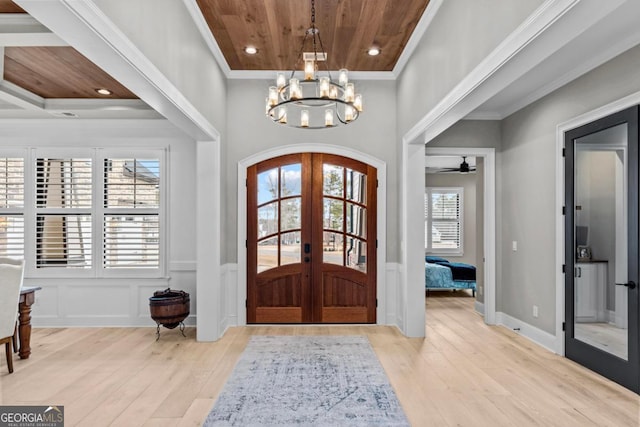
35,156,93,269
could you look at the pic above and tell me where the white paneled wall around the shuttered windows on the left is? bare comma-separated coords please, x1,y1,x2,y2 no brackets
0,119,197,326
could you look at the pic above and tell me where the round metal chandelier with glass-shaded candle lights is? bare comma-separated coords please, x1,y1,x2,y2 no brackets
266,0,362,129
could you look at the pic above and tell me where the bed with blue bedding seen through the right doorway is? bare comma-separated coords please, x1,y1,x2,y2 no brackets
424,256,476,297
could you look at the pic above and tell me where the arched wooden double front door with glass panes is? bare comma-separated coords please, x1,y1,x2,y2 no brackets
247,153,377,323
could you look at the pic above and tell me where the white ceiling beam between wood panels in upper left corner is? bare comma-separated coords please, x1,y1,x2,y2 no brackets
0,13,68,47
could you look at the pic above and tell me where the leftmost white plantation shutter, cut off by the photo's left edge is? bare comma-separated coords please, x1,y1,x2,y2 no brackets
0,154,25,258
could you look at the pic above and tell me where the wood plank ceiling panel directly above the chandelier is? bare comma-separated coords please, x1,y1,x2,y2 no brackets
197,0,429,71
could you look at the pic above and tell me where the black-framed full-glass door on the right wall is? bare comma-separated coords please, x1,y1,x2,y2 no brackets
565,107,640,392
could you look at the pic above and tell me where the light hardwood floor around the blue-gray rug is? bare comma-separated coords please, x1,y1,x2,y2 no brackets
0,293,640,427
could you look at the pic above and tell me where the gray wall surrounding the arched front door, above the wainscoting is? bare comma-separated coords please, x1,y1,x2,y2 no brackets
222,76,401,263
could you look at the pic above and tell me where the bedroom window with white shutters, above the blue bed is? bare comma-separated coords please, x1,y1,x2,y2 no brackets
424,187,463,255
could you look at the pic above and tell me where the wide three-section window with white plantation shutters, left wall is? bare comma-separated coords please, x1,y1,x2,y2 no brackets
0,149,165,277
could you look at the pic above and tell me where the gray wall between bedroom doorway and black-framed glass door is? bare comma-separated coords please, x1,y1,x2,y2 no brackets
497,46,640,334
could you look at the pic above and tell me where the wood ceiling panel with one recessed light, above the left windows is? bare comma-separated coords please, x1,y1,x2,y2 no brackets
4,47,137,99
